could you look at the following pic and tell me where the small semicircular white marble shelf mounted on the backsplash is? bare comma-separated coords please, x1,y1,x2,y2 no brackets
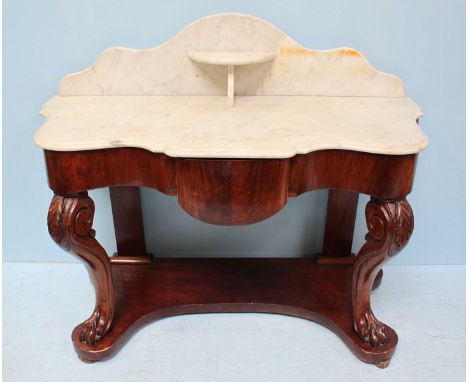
187,52,276,66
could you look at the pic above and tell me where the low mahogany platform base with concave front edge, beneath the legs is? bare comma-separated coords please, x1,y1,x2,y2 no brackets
72,258,398,367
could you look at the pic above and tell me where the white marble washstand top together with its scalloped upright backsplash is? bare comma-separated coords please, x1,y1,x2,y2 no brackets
35,14,427,158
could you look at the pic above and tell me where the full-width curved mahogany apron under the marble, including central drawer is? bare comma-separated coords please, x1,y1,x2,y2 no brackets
45,148,417,225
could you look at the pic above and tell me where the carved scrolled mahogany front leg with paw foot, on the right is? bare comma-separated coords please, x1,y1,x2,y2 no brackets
352,197,414,347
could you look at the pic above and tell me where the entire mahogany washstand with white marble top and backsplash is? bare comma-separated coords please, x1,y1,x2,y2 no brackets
35,14,427,367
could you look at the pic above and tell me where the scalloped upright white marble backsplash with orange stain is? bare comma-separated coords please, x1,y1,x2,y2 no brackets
59,14,404,97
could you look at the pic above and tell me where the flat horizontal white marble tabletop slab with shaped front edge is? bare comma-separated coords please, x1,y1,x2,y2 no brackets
35,96,427,158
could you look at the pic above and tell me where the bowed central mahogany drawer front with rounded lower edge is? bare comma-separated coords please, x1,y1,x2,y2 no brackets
177,159,289,225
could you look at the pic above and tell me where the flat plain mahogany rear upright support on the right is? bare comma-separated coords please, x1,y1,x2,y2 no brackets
322,190,359,256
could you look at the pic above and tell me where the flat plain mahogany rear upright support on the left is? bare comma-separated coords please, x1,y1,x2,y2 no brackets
109,186,147,258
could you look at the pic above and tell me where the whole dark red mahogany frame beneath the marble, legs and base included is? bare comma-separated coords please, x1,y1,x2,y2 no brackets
45,148,417,367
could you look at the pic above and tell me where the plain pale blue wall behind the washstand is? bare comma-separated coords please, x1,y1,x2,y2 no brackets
3,0,465,264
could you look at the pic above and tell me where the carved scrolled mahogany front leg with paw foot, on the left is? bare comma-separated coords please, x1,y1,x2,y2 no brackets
47,192,114,346
